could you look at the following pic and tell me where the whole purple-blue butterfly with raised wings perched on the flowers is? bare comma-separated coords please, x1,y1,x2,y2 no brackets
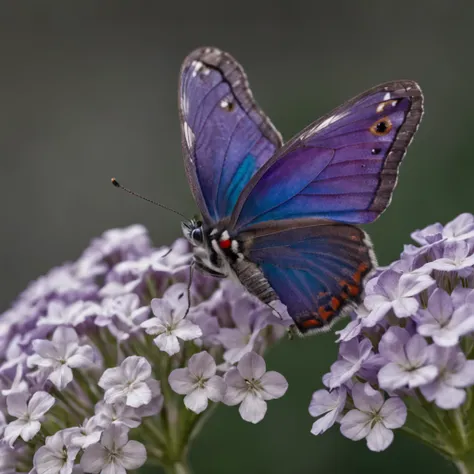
179,48,423,334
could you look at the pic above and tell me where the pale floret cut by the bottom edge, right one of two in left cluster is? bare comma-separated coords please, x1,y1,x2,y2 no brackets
81,425,146,474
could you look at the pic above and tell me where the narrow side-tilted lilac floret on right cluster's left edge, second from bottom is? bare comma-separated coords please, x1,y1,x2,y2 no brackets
327,338,373,389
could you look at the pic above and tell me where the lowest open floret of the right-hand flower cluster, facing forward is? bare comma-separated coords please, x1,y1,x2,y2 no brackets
341,383,407,451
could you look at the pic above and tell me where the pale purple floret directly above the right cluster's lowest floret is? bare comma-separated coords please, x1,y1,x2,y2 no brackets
378,326,438,390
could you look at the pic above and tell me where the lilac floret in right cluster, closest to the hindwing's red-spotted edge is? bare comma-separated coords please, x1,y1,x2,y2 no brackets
363,270,435,327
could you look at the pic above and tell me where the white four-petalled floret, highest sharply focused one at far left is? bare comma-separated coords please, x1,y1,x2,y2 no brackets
28,326,94,390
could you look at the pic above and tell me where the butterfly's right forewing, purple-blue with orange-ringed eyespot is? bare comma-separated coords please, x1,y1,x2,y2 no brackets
231,81,423,230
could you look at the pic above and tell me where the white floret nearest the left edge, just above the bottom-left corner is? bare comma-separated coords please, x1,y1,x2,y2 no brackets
4,392,55,446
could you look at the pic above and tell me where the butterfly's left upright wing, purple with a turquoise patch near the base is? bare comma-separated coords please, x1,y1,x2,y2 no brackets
179,48,281,224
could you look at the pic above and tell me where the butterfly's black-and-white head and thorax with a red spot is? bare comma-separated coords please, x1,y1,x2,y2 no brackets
181,220,244,278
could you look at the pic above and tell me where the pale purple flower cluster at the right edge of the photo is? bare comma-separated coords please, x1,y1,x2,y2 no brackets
309,214,474,460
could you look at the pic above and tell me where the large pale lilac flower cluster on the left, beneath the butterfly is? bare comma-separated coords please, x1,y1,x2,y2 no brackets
0,225,287,474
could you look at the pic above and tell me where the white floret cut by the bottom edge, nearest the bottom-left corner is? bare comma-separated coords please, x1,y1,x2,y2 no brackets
33,428,79,474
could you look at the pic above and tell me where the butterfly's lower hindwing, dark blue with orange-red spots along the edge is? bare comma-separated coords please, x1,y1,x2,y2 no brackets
239,219,376,333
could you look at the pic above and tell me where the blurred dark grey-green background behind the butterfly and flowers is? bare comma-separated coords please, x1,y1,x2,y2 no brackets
0,0,474,474
